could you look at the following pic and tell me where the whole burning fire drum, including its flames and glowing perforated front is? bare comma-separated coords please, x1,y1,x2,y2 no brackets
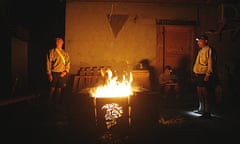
90,69,133,134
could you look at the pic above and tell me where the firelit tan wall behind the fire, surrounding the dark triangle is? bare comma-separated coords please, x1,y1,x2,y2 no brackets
65,1,218,74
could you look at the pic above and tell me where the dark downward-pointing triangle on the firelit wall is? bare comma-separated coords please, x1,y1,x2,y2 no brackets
107,14,128,37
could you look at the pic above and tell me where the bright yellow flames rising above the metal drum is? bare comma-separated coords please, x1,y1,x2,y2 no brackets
90,69,133,97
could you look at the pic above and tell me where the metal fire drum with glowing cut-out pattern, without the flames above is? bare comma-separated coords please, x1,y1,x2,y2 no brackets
93,97,131,131
